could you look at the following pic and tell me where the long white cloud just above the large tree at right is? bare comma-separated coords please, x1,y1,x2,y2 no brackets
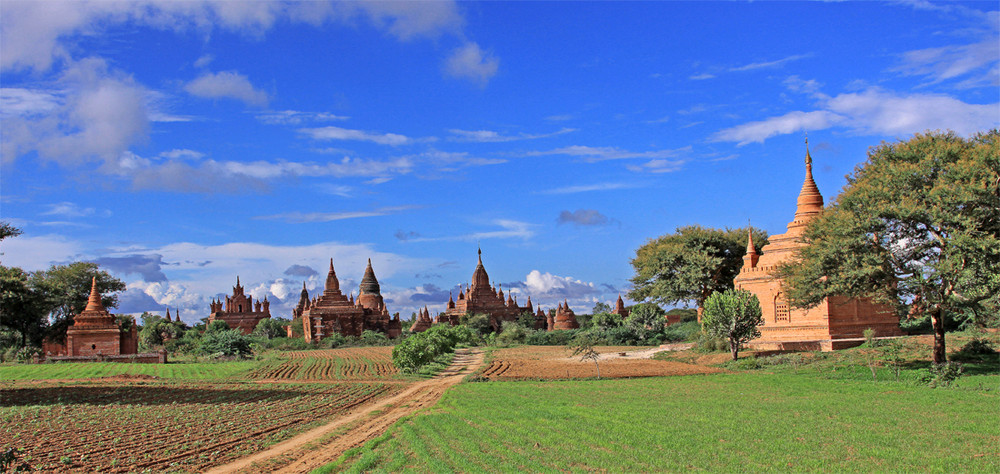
712,88,1000,146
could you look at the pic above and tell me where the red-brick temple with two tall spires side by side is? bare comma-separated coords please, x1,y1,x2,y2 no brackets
293,258,402,342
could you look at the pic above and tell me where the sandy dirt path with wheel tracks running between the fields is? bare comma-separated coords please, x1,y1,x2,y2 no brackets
206,349,483,474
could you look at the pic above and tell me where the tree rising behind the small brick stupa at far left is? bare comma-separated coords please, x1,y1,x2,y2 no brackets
29,262,125,341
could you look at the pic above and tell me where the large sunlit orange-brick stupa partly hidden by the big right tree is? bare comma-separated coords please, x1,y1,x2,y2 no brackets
733,143,902,351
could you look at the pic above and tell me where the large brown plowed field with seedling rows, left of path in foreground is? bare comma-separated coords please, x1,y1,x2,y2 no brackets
0,382,402,472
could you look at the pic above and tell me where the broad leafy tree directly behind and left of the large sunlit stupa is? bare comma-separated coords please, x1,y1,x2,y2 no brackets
628,225,767,314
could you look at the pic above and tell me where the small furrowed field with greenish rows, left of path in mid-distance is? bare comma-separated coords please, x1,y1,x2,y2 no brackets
249,347,399,381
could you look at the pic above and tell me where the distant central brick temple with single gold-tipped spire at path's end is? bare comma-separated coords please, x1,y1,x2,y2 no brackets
435,249,535,331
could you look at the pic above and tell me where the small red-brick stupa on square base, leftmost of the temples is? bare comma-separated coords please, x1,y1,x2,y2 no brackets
45,277,139,357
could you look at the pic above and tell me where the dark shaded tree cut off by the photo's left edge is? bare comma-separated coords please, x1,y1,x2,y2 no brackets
0,266,46,347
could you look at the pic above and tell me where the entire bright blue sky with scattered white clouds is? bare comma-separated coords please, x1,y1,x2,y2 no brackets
0,0,1000,322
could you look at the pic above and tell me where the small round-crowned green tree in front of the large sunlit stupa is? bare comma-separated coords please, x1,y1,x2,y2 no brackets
701,290,764,360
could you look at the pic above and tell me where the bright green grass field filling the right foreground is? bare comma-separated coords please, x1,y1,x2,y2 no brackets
324,371,1000,472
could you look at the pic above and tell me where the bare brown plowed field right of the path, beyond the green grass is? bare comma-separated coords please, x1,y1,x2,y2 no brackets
481,346,722,380
